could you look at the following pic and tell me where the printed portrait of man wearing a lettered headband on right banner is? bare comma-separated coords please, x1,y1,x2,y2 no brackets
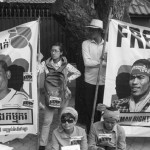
112,59,150,112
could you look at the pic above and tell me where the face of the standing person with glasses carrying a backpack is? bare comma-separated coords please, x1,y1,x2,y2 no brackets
51,46,63,60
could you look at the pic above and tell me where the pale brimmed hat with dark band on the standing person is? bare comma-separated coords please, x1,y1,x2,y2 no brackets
86,19,103,30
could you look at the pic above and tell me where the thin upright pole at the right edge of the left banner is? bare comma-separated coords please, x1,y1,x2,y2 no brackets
37,16,41,150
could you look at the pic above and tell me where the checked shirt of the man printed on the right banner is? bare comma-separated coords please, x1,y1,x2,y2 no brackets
112,96,150,113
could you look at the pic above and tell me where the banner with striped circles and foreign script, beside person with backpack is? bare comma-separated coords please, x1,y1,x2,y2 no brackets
0,21,39,135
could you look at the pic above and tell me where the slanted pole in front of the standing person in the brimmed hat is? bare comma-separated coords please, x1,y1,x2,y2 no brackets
91,7,112,125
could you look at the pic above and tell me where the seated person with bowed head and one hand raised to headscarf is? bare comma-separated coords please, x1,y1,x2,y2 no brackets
88,104,126,150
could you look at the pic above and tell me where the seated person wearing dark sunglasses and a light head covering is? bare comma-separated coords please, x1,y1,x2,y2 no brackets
51,107,87,150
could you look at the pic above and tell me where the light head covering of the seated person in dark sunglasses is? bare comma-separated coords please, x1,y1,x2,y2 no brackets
60,107,78,122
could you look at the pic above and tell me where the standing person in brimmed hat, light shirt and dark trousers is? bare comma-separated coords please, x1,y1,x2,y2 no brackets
82,19,107,133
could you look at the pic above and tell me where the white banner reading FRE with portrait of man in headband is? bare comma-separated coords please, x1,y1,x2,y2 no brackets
104,19,150,137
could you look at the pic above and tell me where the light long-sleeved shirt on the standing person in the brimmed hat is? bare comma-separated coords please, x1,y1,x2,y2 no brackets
82,40,107,85
